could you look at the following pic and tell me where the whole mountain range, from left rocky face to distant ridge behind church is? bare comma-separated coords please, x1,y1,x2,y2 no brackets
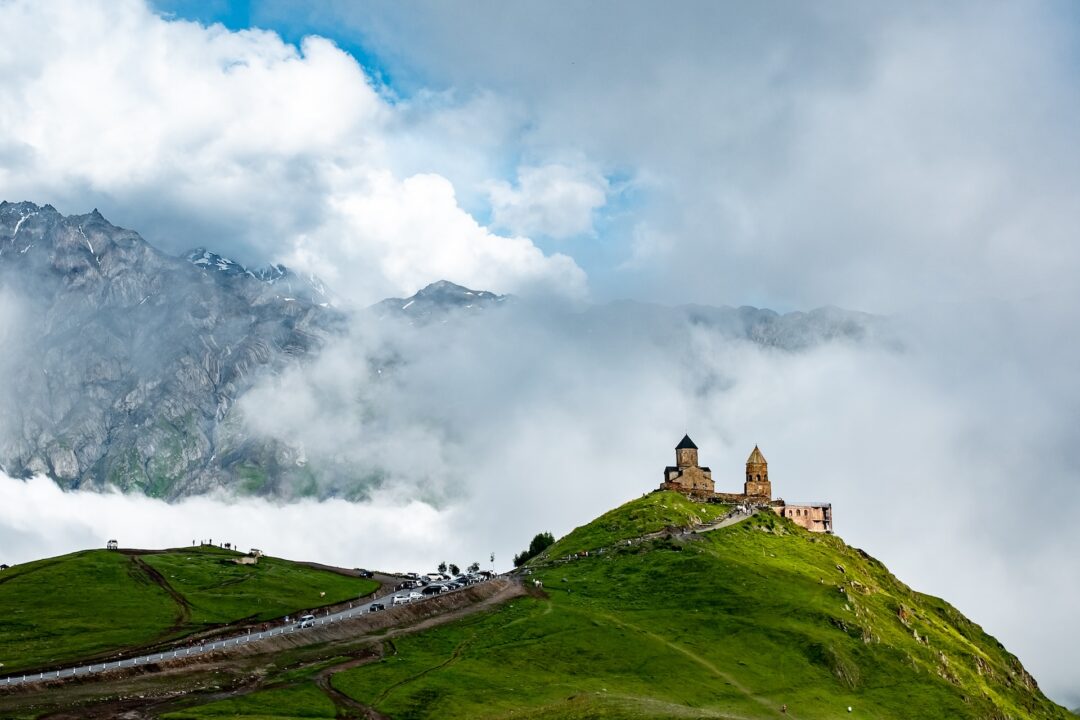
0,202,883,498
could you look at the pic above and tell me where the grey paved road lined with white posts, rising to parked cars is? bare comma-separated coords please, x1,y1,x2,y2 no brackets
0,588,490,688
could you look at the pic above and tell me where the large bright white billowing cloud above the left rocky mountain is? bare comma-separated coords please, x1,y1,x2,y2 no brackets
0,0,584,302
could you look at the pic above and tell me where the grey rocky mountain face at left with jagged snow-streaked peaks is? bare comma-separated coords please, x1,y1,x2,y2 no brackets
0,203,341,498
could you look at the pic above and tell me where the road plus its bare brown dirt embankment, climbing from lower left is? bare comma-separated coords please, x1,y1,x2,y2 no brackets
0,578,516,691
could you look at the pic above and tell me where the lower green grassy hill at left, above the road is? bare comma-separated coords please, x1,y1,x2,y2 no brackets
0,547,378,674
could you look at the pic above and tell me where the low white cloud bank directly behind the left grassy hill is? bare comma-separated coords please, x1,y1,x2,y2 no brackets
0,473,473,571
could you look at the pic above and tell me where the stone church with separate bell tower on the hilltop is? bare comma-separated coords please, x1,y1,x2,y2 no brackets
660,435,833,533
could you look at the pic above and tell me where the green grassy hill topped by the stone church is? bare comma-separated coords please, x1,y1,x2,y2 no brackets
165,493,1071,720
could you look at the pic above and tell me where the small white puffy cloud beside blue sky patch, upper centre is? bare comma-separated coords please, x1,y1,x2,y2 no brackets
488,163,608,239
